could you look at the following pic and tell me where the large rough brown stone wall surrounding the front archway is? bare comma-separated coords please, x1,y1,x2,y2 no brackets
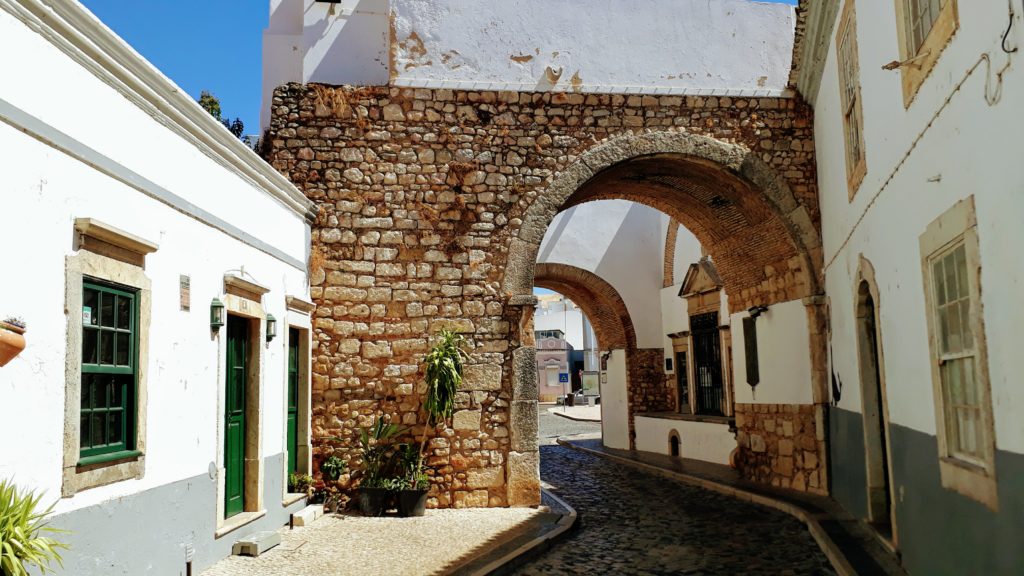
263,84,818,507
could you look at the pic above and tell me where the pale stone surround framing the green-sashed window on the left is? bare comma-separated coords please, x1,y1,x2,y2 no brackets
60,218,158,498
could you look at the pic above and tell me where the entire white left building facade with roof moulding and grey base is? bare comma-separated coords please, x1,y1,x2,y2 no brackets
0,0,313,575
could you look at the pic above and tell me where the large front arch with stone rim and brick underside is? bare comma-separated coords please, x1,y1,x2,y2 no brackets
503,131,822,311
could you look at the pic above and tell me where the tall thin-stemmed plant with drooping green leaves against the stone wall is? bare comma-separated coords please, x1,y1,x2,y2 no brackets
410,330,466,483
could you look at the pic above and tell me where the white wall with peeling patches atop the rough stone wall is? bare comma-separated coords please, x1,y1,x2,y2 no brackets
262,0,795,127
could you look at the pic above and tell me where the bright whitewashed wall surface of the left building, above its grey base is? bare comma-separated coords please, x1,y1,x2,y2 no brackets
0,5,309,515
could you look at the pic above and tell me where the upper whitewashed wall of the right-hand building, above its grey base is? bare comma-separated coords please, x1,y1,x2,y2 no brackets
815,2,1024,453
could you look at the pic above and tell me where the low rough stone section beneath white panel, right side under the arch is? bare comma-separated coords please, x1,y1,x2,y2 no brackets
735,404,828,494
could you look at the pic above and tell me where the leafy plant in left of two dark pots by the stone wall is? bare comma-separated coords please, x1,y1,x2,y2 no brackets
359,418,402,516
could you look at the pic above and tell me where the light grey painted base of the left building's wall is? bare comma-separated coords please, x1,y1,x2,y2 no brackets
51,454,305,576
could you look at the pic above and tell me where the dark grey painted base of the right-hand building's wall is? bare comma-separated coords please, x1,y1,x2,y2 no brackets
828,408,1024,576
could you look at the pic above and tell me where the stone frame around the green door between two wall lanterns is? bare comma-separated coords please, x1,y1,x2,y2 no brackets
214,274,270,538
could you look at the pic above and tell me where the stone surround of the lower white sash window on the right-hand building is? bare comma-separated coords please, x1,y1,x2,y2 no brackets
920,195,999,511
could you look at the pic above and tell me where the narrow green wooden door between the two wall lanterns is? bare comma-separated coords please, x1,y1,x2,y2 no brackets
224,316,249,518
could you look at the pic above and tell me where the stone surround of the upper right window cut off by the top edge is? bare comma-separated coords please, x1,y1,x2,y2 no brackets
895,0,959,109
